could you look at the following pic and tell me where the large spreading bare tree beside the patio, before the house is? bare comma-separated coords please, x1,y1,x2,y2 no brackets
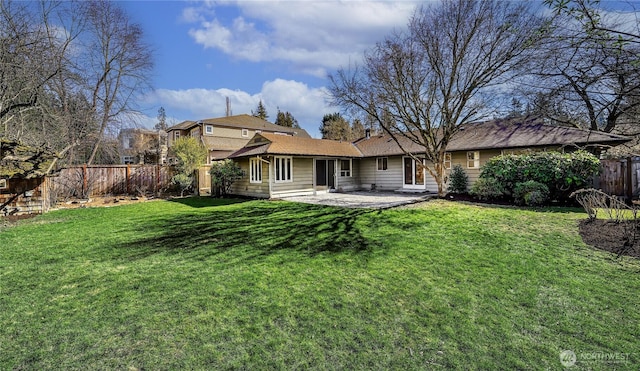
330,0,545,195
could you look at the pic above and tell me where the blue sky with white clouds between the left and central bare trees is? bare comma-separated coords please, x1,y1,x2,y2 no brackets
120,0,416,137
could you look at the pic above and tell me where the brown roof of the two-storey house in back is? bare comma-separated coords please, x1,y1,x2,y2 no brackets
167,114,311,138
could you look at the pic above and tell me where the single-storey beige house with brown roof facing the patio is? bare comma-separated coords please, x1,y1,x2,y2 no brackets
229,121,630,198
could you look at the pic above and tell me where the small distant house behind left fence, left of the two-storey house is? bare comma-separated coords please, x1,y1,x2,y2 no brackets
118,128,168,164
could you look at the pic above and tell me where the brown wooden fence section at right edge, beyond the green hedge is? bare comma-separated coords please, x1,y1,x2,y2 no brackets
595,157,640,200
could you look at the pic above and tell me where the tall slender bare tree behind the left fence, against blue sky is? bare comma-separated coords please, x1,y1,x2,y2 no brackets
85,0,153,164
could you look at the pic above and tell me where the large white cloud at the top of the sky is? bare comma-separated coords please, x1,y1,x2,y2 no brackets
183,1,416,77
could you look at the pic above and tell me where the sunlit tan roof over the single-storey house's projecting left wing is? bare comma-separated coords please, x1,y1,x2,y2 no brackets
229,133,362,158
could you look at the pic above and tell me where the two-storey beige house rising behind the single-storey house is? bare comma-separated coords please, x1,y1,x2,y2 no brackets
167,114,310,164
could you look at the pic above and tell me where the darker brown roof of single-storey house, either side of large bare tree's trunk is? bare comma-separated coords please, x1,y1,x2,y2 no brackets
356,120,631,157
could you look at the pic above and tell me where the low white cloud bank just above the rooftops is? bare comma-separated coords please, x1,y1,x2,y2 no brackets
141,79,339,137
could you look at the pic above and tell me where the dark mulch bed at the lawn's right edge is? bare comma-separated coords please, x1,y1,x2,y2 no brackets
579,219,640,258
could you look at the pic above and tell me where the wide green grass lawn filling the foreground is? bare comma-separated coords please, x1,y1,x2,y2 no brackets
0,198,640,370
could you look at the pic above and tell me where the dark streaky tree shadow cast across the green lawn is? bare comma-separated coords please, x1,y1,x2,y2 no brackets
118,199,380,259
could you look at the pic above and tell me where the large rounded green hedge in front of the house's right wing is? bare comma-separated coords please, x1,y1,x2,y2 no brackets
480,151,600,201
